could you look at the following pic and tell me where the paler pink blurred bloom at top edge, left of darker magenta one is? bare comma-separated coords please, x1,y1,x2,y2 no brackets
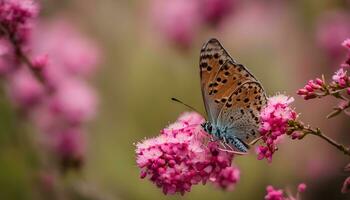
150,0,201,47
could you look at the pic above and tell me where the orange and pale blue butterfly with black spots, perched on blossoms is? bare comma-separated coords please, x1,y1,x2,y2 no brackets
199,39,267,152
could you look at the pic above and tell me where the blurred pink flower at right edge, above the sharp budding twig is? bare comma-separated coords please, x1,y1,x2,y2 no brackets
317,11,350,62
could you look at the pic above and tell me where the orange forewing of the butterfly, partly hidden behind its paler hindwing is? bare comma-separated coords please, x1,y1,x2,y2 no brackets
199,39,234,123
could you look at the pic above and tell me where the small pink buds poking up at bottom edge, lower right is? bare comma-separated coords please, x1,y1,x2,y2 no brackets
265,183,306,200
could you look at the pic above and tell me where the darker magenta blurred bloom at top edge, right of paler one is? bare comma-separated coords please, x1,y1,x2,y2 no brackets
199,0,237,25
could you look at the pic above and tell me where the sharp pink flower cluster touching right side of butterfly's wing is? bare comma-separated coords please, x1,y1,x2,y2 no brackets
257,95,297,162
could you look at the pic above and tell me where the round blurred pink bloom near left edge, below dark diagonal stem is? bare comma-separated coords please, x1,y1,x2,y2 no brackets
7,68,45,107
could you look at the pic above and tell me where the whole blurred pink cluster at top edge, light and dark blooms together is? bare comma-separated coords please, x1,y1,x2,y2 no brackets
150,0,236,47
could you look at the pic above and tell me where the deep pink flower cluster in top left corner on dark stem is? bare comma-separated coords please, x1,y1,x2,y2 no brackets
0,0,39,44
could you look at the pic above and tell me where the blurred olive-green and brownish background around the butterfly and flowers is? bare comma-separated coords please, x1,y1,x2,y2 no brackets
0,0,350,200
